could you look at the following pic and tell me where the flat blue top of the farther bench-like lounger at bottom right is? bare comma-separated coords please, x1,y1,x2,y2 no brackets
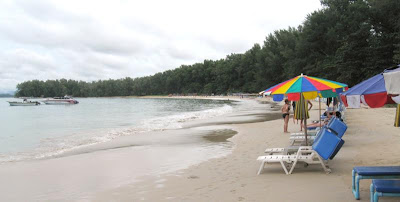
353,166,400,176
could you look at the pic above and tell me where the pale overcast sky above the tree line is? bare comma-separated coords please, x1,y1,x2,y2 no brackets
0,0,321,93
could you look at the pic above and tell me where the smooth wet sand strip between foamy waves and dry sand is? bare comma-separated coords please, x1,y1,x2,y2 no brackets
0,96,282,201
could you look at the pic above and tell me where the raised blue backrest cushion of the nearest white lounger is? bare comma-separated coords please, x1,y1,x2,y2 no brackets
312,129,341,160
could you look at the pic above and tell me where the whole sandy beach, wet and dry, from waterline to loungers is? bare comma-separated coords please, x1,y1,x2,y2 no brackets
0,97,400,201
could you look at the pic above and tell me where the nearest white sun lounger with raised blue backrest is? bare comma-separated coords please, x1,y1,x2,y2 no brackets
257,130,344,175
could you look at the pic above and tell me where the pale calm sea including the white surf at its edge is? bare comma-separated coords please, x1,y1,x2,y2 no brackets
0,98,235,163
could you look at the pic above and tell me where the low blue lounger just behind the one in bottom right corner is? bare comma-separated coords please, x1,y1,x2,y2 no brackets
352,166,400,200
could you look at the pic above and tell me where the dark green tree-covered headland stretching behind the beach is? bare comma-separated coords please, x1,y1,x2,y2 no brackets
15,0,400,97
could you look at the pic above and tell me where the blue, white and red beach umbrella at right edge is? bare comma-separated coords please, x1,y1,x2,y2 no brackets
341,67,400,108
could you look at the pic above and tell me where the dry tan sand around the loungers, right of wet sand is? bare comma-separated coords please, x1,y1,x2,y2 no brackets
94,100,400,201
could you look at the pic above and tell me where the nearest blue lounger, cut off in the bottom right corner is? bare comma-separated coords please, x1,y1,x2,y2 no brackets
370,180,400,202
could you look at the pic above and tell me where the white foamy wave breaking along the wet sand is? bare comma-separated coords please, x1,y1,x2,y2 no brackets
0,104,233,163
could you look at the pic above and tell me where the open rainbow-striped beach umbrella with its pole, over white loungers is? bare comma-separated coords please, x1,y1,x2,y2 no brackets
264,74,347,144
